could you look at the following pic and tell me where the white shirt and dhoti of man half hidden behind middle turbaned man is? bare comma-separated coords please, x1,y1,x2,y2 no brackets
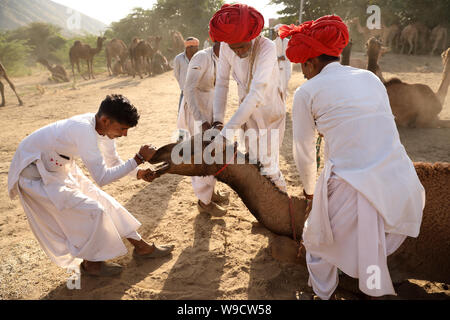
178,47,217,204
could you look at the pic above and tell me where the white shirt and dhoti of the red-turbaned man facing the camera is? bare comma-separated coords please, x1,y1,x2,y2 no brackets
214,37,286,189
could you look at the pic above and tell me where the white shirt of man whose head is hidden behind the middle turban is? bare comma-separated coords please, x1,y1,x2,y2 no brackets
183,47,218,123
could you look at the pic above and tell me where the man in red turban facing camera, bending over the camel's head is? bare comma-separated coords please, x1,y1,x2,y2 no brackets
209,4,286,190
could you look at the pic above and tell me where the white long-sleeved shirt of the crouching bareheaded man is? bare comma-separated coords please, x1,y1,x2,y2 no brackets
8,113,137,198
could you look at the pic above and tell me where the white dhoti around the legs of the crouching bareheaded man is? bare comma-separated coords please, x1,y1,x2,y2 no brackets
18,164,141,268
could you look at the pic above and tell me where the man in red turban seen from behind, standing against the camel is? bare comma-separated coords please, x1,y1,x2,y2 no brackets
286,16,425,299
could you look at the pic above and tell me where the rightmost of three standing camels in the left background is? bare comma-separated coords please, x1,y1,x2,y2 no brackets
130,37,162,79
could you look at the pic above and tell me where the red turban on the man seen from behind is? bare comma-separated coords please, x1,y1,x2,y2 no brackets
278,15,349,63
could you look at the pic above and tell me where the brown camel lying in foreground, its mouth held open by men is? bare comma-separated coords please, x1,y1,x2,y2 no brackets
146,136,450,283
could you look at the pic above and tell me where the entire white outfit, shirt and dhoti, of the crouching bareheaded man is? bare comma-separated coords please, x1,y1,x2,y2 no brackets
8,113,141,267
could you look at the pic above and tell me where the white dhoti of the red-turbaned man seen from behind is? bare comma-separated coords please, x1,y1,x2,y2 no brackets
305,175,406,299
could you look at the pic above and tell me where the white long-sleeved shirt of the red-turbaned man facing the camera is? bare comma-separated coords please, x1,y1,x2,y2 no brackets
213,37,286,130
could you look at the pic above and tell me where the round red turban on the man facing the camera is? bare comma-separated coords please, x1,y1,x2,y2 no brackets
209,3,264,44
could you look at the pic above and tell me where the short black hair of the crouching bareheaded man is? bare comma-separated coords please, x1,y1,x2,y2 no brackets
97,94,140,127
